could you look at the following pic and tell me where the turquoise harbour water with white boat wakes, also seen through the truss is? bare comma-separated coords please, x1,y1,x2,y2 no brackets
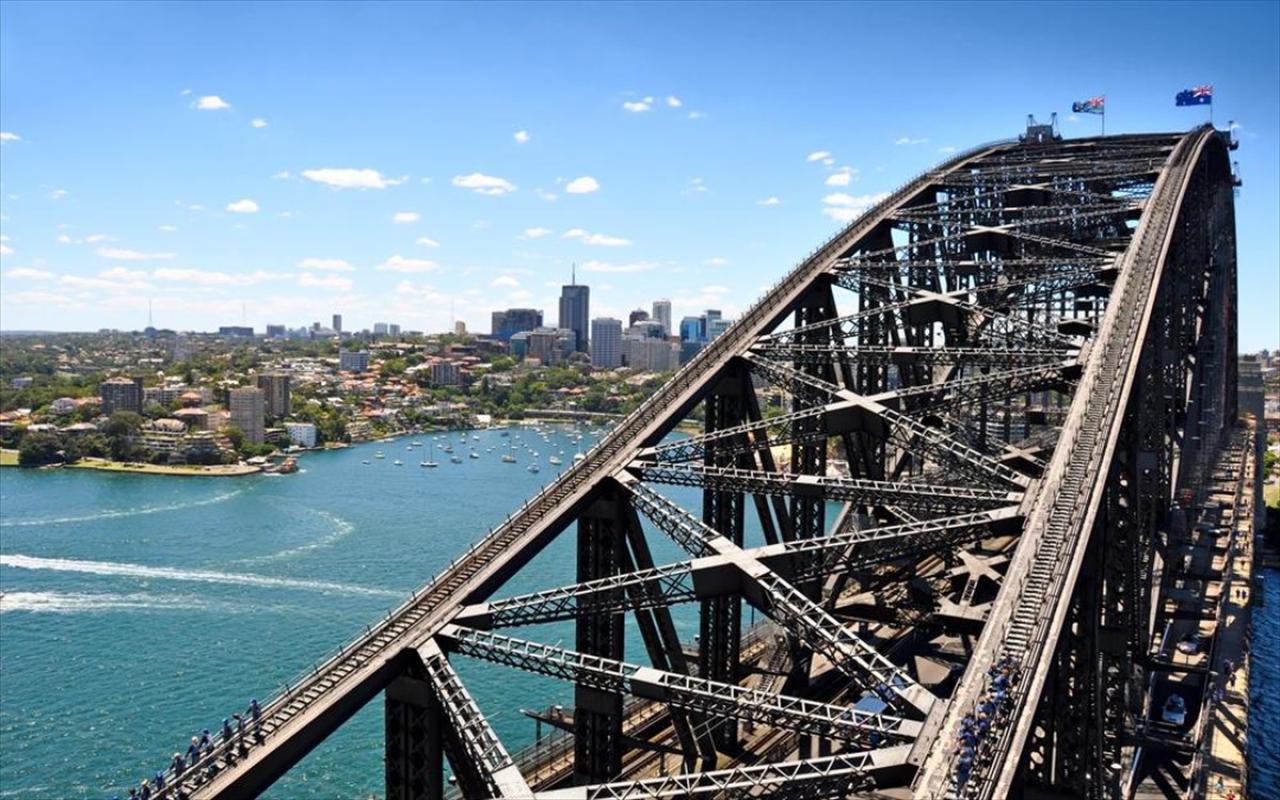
0,426,698,797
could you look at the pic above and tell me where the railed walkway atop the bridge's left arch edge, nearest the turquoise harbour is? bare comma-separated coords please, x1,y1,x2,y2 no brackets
145,134,1014,799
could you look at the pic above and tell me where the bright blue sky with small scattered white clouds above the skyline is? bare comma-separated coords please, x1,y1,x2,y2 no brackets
0,1,1280,349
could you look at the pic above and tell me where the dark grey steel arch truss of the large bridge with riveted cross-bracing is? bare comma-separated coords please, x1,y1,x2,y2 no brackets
142,127,1235,800
